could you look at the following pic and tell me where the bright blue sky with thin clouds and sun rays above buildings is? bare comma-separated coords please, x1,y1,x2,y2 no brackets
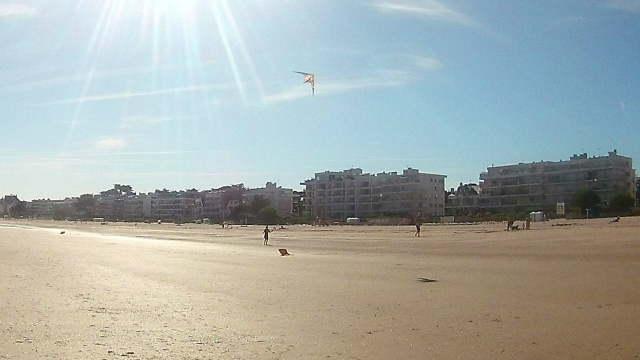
0,0,640,200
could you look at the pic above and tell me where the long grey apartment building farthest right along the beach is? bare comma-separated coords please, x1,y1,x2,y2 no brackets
479,150,635,212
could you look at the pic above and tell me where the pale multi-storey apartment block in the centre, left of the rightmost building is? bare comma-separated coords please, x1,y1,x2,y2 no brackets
301,168,446,220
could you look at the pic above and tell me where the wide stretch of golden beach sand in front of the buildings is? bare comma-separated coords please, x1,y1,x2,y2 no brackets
0,218,640,359
